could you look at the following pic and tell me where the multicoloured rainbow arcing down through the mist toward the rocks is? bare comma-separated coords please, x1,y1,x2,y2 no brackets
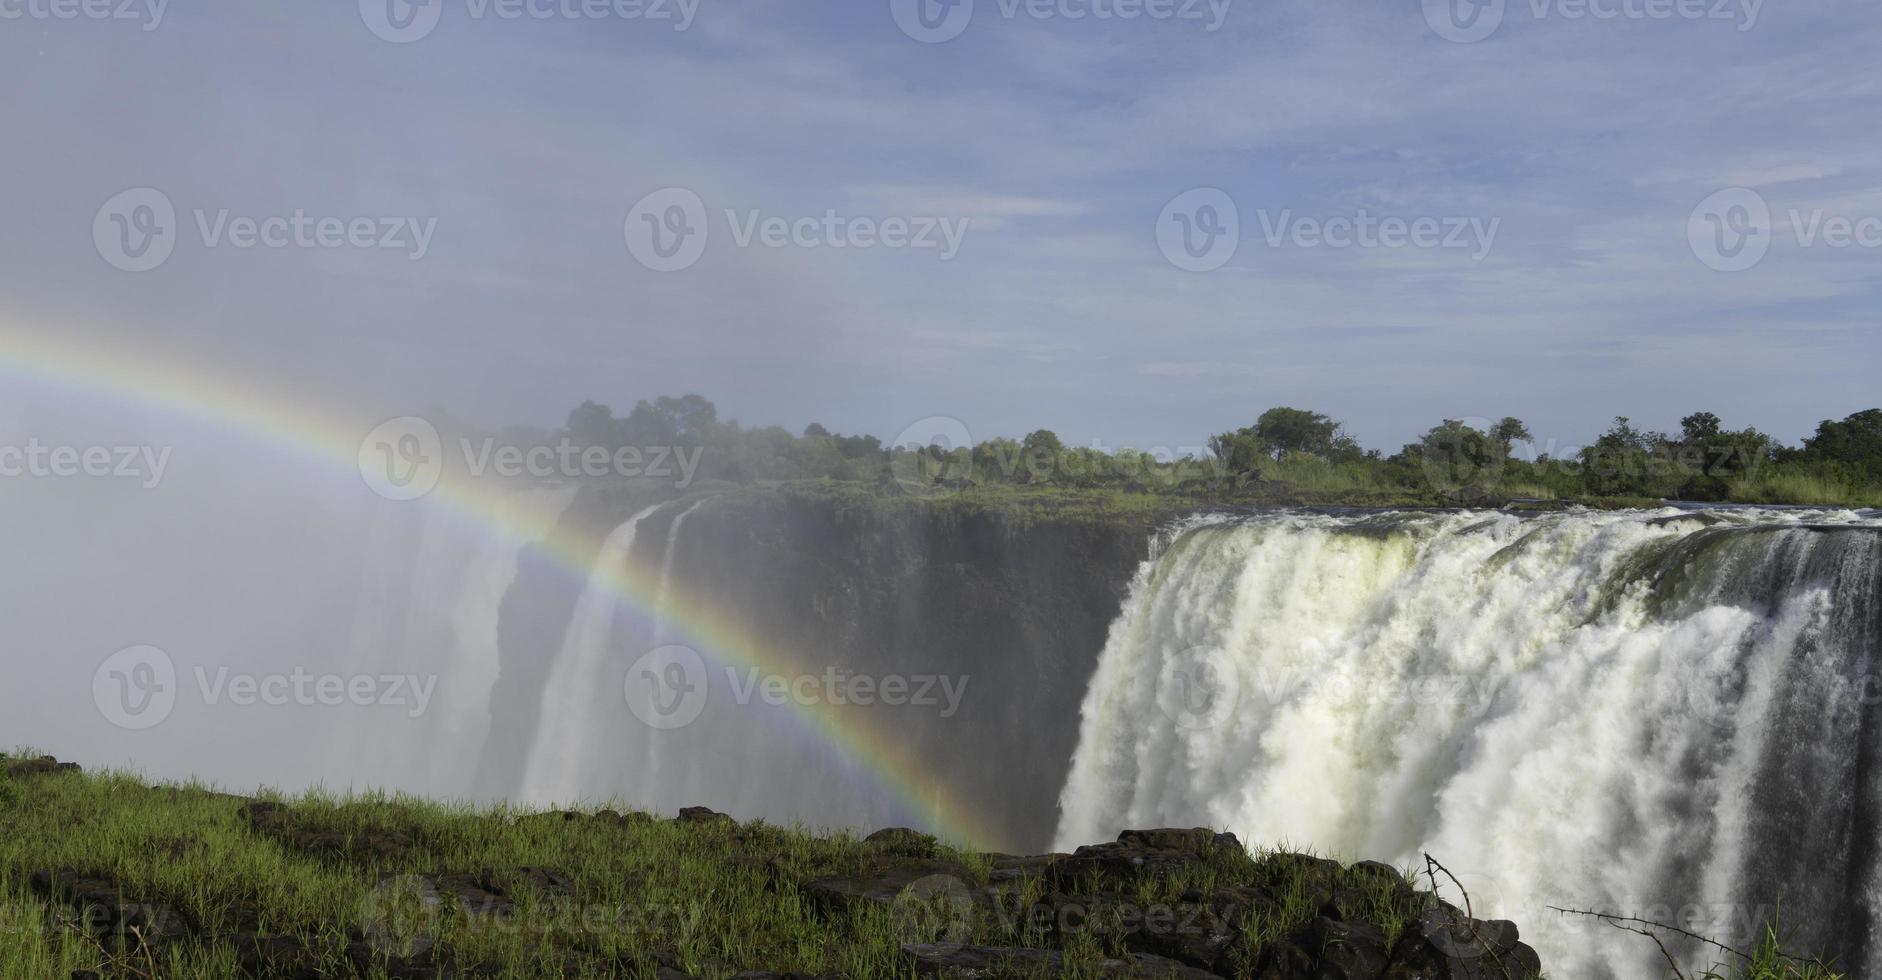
0,322,999,846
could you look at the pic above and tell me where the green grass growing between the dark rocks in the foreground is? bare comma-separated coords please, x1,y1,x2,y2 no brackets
0,756,1475,980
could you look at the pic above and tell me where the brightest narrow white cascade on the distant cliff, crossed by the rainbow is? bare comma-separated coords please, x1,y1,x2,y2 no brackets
521,504,659,803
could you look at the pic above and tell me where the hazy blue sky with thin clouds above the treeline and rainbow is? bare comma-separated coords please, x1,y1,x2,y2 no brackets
0,0,1882,450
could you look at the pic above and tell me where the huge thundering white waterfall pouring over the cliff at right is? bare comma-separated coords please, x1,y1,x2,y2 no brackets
1058,510,1882,978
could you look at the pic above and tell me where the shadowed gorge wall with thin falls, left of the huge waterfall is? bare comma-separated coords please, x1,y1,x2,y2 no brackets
478,489,1152,850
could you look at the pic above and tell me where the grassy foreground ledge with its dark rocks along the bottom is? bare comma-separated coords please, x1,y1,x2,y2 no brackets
0,756,1835,980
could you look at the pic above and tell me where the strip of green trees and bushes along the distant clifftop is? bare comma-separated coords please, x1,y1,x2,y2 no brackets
436,395,1882,512
